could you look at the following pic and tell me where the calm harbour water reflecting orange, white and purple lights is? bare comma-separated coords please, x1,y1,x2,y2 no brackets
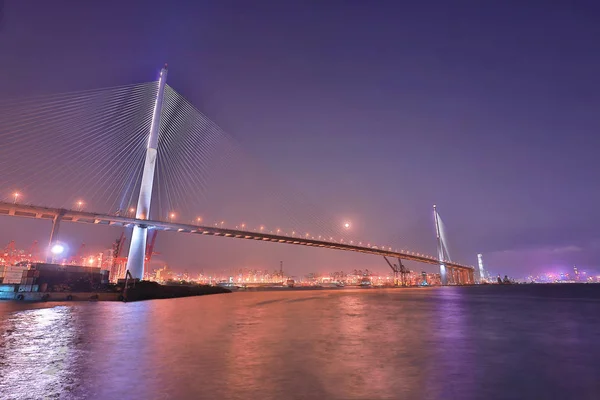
0,285,600,399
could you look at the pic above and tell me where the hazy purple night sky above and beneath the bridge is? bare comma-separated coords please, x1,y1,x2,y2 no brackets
0,0,600,276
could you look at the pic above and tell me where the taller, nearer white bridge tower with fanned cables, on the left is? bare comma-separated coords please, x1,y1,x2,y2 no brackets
127,65,167,280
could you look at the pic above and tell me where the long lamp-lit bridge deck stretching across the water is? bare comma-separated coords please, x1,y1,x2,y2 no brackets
0,202,474,284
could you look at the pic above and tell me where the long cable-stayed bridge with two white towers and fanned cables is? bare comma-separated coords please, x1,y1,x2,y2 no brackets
0,66,473,284
